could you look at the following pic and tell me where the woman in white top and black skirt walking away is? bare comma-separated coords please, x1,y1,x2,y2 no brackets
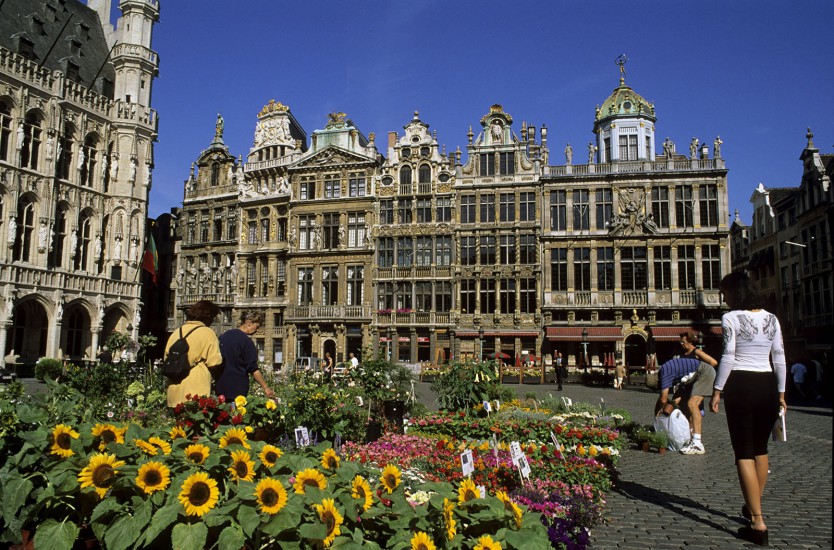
710,272,787,546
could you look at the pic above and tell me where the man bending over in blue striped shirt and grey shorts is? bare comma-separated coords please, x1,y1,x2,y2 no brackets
655,357,715,455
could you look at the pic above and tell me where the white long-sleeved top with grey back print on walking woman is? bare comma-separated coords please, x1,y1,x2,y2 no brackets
715,309,785,392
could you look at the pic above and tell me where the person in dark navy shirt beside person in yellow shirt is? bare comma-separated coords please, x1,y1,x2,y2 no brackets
215,311,275,401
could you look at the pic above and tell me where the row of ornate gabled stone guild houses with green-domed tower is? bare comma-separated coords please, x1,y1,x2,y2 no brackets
174,73,730,374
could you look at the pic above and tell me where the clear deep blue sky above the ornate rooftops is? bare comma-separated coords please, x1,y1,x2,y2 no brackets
141,0,834,223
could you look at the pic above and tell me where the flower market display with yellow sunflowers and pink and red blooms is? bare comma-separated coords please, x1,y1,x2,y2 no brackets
0,361,622,550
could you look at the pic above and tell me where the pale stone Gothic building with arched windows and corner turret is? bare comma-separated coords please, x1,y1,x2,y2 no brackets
0,0,159,365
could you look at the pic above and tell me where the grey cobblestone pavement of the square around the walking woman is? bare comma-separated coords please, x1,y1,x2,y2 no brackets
417,384,832,550
